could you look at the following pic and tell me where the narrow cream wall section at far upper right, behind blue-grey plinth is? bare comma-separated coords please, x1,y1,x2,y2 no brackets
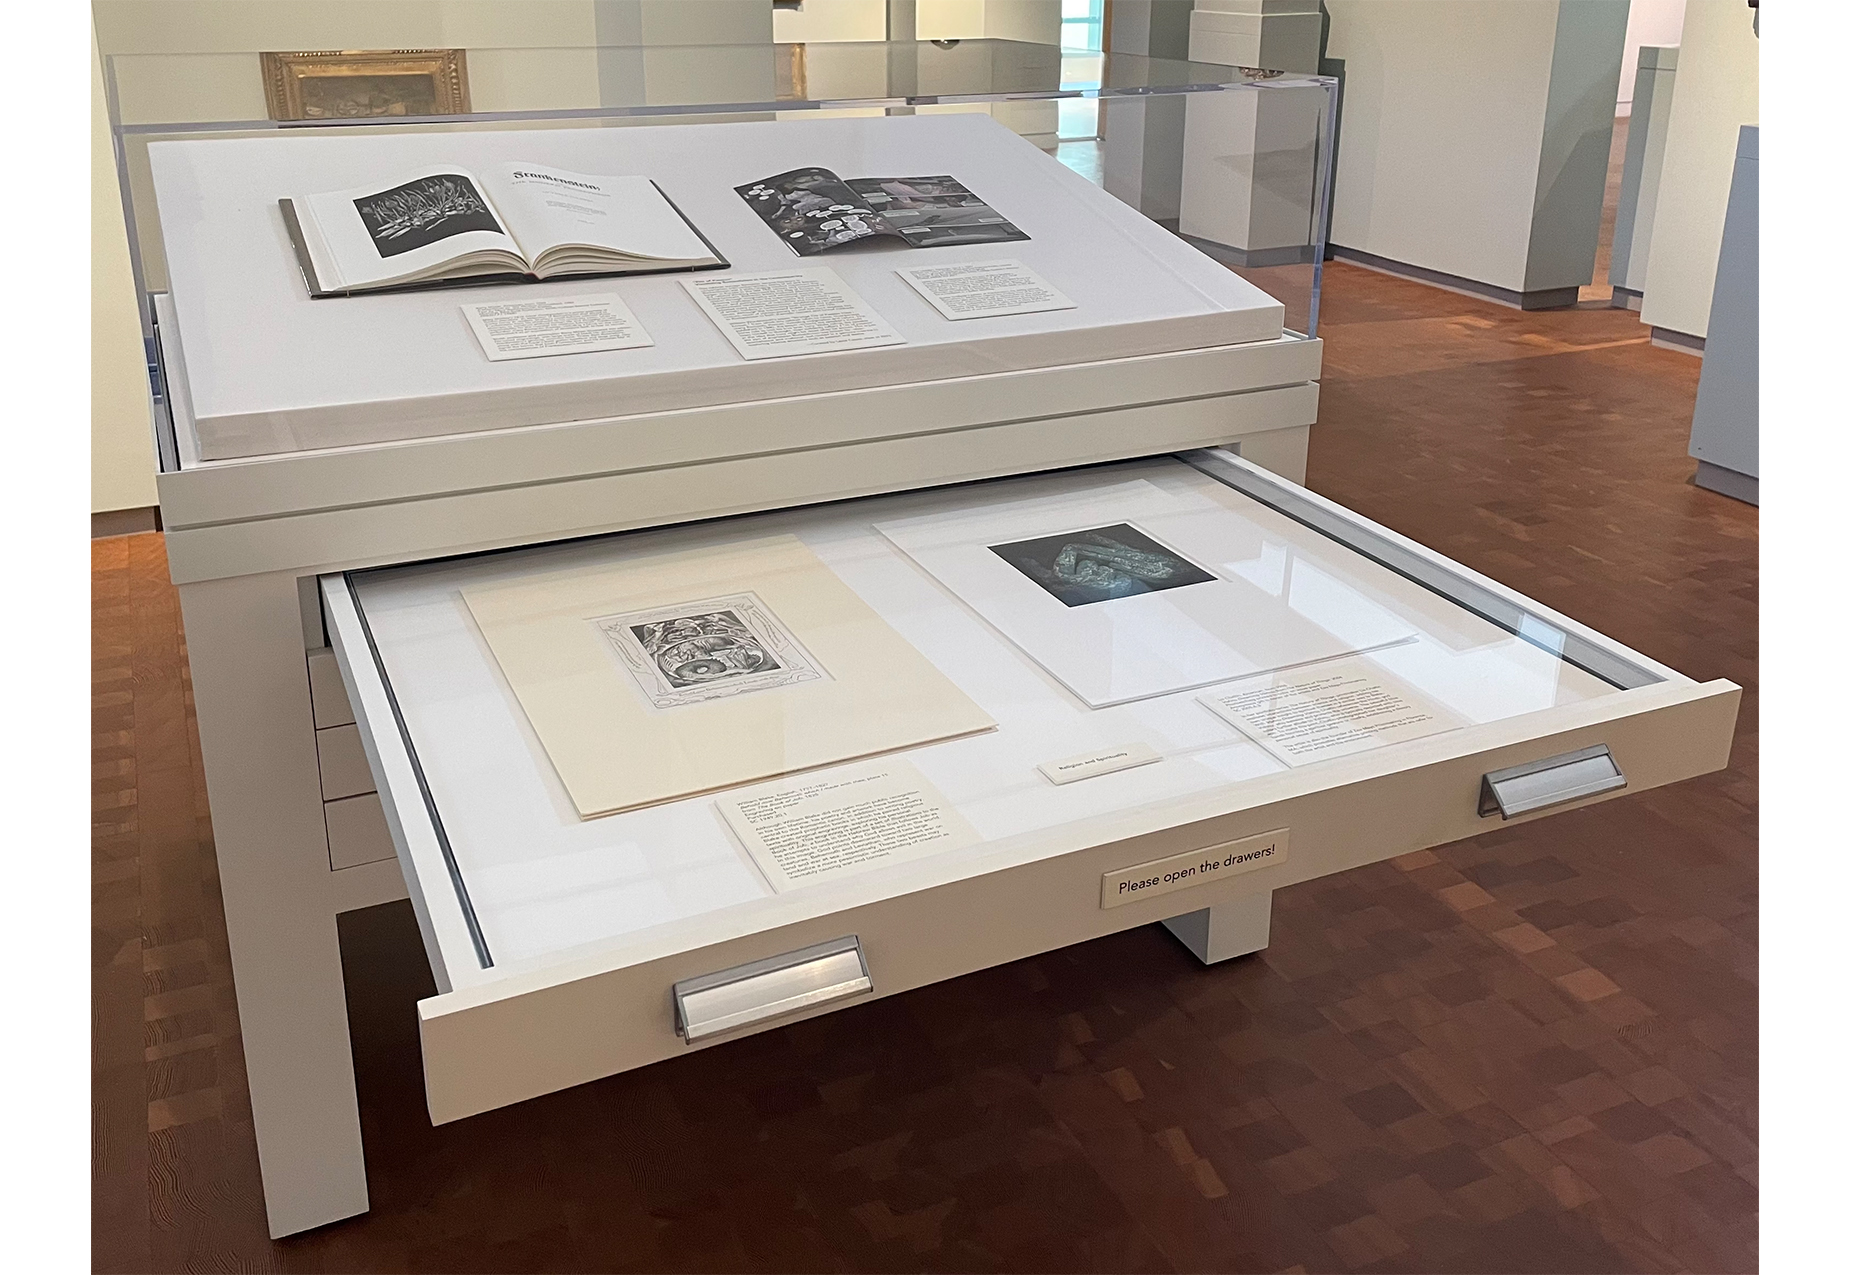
1639,0,1759,337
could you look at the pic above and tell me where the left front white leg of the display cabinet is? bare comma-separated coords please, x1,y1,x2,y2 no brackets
179,576,366,1236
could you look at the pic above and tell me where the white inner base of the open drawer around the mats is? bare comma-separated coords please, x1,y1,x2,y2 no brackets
357,459,1615,968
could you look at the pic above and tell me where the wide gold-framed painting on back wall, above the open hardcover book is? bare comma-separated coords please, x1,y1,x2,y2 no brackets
263,48,470,120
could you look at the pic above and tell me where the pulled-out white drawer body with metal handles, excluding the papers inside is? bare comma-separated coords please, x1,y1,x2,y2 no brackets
322,452,1739,1123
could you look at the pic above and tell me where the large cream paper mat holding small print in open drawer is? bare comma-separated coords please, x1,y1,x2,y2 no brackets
463,537,995,818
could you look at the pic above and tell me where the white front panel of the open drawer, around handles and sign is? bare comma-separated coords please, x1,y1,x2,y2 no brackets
418,683,1741,1123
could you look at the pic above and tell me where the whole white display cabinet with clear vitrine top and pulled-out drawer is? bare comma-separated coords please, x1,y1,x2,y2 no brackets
105,41,1739,1234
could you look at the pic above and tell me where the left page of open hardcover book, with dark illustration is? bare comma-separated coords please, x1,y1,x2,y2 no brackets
298,165,527,291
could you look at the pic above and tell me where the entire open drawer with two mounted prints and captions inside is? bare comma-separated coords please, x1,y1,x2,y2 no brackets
322,452,1739,1123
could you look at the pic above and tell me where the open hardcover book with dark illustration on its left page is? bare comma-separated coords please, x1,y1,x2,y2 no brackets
281,165,729,296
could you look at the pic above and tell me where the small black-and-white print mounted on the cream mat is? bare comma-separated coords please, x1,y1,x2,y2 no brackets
592,592,829,709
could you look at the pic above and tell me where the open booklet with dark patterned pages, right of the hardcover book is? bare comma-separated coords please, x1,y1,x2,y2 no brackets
733,168,1027,257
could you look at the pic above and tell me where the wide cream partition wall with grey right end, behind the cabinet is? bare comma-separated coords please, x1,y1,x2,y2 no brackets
1328,0,1628,300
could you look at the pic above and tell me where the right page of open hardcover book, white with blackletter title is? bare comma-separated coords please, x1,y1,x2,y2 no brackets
496,165,714,278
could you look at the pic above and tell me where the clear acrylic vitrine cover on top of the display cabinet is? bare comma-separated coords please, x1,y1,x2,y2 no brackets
105,39,1334,470
